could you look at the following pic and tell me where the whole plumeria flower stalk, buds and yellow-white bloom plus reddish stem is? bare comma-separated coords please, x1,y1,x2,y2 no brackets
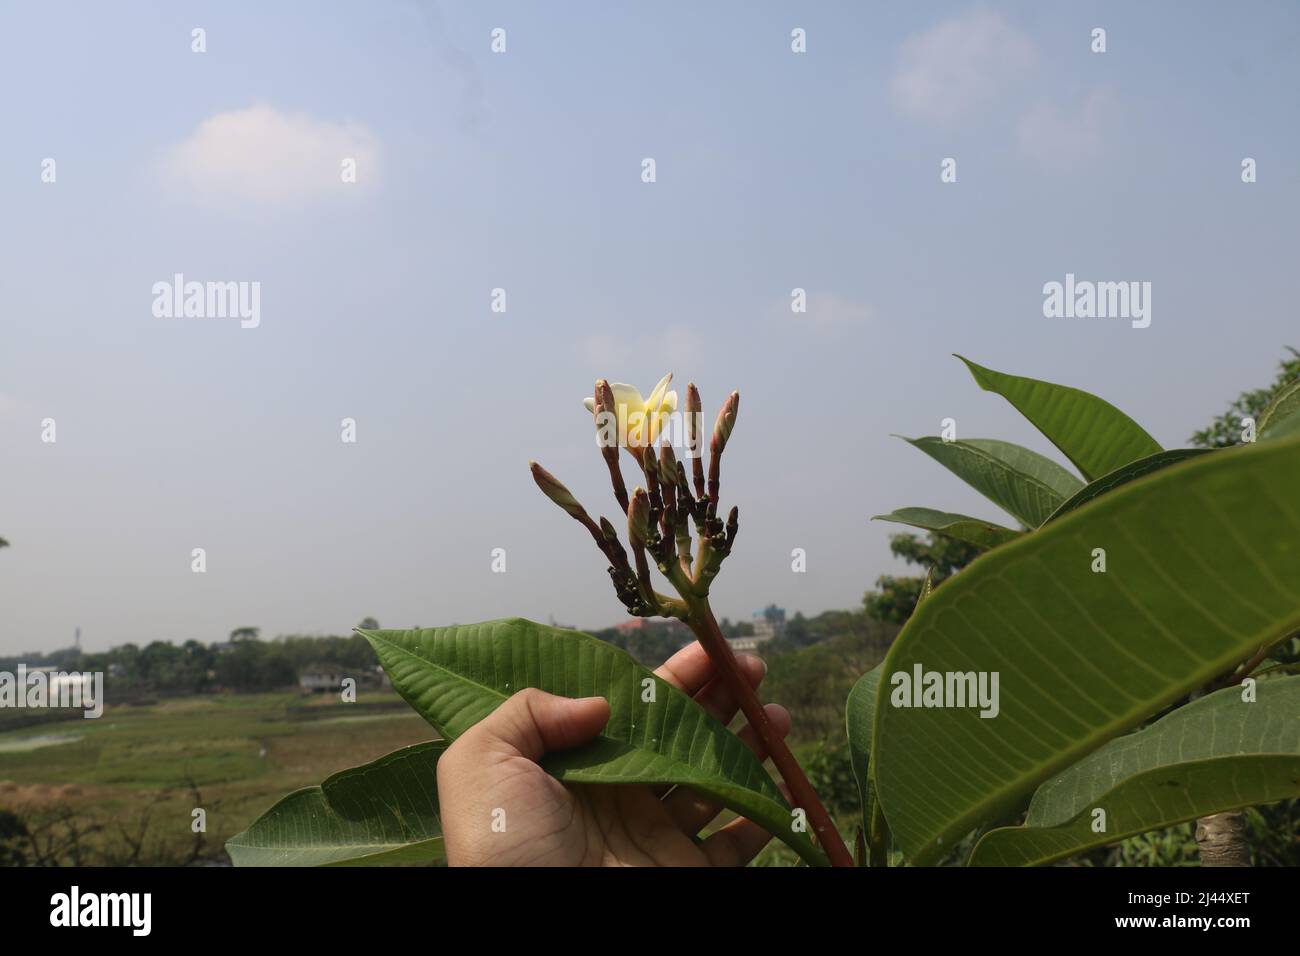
530,373,853,866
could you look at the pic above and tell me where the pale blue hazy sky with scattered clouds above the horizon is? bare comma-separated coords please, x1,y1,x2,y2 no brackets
0,1,1300,653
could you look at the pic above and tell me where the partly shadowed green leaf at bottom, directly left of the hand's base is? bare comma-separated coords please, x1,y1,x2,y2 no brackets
226,740,447,866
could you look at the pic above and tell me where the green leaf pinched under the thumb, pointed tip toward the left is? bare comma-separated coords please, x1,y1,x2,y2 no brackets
360,618,826,864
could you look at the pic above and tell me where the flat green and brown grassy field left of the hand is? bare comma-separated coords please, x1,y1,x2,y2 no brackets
0,691,436,864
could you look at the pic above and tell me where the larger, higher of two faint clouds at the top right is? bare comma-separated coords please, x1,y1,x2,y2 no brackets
891,10,1037,124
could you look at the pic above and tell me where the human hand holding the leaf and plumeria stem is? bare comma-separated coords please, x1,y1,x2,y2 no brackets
438,643,790,866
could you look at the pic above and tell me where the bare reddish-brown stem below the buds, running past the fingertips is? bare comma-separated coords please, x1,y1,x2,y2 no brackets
686,598,853,866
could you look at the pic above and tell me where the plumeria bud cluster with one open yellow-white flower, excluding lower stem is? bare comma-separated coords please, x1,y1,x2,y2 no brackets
530,373,740,620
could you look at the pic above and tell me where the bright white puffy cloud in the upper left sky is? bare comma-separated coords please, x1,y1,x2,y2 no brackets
163,105,378,204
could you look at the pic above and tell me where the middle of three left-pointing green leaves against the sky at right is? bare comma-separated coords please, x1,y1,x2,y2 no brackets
898,436,1083,528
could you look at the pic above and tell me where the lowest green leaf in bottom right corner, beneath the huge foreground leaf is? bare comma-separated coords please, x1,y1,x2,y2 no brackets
970,678,1300,866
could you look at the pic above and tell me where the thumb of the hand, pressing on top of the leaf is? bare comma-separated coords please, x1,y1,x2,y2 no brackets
464,687,610,762
